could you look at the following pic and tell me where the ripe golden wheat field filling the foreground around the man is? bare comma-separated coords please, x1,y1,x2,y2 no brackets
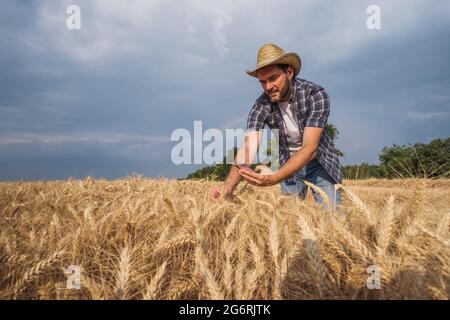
0,175,450,299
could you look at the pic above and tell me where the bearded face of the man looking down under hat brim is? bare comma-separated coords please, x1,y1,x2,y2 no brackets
257,65,293,102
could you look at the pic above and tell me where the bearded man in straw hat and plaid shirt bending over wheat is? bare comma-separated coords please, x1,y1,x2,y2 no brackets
210,44,343,210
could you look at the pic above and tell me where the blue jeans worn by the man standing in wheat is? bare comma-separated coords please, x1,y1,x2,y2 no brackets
281,159,342,210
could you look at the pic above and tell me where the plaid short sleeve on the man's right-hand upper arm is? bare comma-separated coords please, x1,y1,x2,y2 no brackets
305,89,330,128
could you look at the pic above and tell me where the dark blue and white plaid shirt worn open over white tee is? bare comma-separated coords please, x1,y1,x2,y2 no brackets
247,78,343,183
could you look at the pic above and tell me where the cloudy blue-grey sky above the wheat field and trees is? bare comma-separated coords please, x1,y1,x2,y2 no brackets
0,0,450,180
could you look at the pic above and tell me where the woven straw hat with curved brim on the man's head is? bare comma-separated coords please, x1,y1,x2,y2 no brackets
245,43,302,78
